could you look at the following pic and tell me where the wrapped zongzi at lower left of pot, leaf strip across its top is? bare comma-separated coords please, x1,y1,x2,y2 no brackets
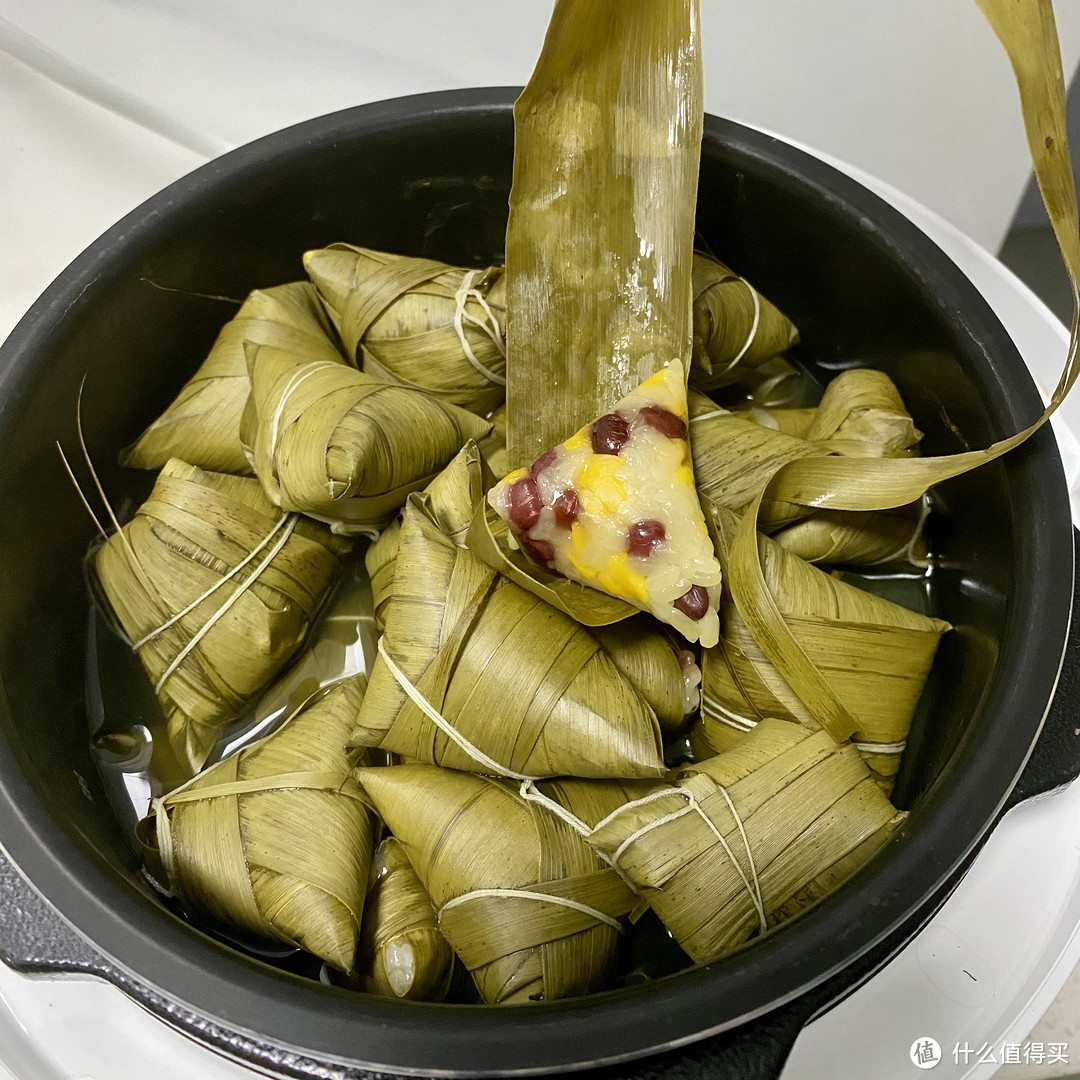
139,673,375,972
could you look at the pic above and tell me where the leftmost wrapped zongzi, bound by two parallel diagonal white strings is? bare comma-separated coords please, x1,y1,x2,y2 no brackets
91,460,350,771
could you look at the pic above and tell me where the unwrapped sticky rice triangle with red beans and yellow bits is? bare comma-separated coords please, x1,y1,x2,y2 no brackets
488,360,725,646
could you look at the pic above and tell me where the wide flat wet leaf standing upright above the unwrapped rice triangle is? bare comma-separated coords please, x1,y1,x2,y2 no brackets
507,0,703,468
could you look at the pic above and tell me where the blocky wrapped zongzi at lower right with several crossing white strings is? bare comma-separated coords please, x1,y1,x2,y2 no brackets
567,718,906,962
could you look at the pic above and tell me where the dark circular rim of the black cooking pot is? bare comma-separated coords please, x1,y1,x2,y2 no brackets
0,87,1072,1075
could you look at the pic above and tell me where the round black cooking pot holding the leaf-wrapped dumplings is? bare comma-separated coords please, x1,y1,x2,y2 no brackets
0,90,1072,1074
